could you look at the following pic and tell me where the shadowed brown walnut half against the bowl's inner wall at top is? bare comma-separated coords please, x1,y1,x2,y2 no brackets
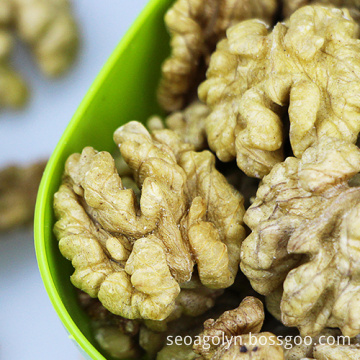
158,0,277,111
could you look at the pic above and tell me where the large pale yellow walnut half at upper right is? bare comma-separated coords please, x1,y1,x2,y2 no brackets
199,5,360,178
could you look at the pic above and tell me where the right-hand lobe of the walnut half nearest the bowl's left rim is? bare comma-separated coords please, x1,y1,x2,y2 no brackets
179,151,245,288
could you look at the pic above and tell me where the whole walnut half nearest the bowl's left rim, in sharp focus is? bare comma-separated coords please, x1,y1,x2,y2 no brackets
54,121,245,320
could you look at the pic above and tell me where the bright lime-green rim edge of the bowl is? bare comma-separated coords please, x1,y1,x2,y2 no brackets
34,0,166,360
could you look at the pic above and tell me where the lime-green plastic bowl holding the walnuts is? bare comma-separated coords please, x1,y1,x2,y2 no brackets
34,0,173,360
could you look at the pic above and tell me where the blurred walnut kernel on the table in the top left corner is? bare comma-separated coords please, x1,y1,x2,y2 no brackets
0,0,79,108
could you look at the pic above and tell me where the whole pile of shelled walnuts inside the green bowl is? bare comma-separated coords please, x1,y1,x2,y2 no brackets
54,0,360,360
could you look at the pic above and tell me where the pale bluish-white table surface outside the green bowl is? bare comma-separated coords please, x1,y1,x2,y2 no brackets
0,0,147,360
